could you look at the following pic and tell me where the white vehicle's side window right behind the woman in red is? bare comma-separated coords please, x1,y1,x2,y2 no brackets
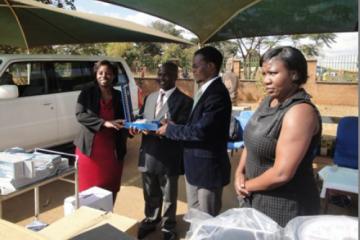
54,61,95,92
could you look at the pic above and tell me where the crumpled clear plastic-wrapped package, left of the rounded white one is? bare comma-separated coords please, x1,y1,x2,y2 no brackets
184,208,283,240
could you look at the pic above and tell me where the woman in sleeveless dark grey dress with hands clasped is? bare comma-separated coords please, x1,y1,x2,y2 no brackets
234,47,321,227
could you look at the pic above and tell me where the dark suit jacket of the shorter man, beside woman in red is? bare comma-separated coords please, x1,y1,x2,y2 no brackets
138,88,193,176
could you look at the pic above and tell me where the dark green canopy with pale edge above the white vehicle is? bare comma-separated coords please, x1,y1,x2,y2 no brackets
0,0,189,48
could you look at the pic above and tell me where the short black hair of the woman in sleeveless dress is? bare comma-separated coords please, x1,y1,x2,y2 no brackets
260,46,308,85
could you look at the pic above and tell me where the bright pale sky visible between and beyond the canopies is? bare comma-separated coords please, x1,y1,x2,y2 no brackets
75,0,358,57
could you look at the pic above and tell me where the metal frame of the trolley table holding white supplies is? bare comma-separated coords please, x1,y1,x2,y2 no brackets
0,148,79,219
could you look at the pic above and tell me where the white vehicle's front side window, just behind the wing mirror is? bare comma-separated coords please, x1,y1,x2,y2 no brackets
6,62,47,97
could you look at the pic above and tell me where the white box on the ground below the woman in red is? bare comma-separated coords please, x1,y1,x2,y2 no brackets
64,187,113,216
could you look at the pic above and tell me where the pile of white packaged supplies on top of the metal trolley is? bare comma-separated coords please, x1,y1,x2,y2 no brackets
0,148,69,194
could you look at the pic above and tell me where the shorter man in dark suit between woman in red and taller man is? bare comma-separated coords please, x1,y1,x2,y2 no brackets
134,62,193,239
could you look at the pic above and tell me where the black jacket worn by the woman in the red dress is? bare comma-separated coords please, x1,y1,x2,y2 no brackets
74,85,128,161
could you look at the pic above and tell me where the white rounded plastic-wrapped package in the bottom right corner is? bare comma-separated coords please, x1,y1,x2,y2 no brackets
284,215,358,240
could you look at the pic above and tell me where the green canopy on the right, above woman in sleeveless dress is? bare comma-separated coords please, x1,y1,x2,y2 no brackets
102,0,358,43
